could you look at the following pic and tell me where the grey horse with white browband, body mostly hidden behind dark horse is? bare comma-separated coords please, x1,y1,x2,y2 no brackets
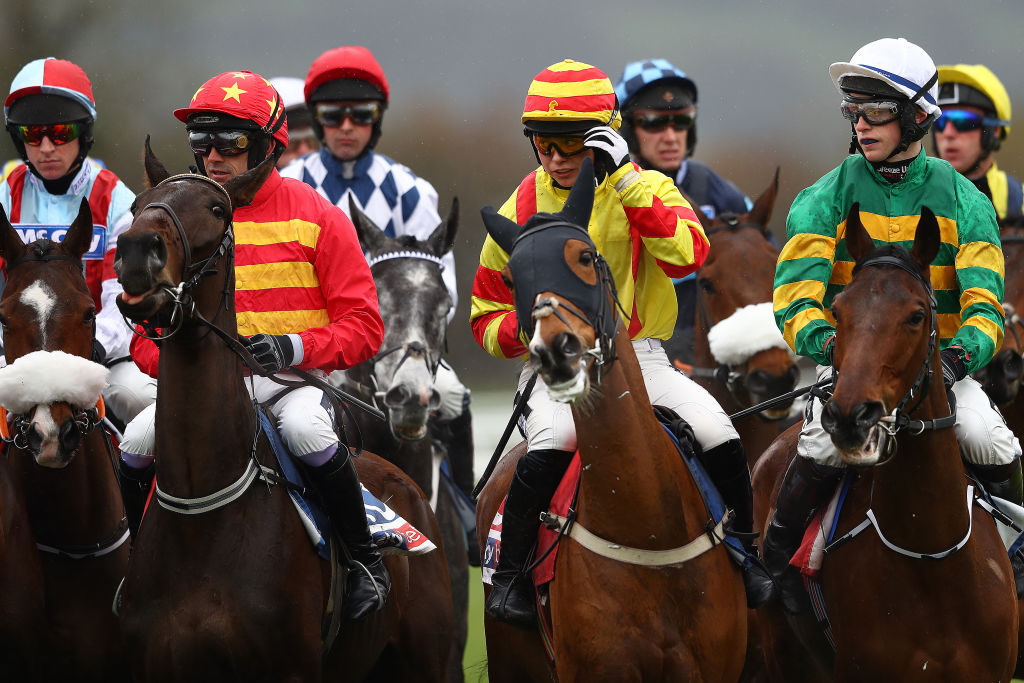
331,200,469,683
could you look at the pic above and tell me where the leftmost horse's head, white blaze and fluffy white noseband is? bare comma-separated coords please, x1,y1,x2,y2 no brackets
0,200,108,468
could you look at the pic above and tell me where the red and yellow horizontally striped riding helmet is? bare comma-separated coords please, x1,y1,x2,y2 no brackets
522,59,623,133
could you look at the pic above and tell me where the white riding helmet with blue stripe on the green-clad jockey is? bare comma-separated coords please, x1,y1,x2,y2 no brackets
828,38,942,156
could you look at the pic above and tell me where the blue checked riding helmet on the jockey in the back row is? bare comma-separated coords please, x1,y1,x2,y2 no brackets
615,58,697,160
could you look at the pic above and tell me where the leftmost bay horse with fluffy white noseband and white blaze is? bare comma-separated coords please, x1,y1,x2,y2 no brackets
0,200,129,682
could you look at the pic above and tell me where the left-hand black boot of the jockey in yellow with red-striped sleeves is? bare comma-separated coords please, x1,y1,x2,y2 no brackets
483,451,572,629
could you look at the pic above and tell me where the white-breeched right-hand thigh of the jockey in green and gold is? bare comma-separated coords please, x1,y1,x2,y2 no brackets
953,375,1021,465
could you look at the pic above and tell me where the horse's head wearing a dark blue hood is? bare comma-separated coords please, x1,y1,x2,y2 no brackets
481,159,620,401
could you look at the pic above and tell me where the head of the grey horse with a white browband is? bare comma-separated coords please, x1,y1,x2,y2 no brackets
349,194,459,440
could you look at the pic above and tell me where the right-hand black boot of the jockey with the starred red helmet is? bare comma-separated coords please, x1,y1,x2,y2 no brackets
308,446,391,620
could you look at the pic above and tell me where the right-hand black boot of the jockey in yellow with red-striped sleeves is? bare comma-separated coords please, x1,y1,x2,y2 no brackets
700,439,775,607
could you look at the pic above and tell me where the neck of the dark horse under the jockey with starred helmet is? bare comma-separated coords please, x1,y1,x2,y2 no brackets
156,272,256,497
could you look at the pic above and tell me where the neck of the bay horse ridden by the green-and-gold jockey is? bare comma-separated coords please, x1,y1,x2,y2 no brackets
871,366,969,551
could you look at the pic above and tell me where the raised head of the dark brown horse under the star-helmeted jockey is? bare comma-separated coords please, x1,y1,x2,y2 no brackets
114,138,273,326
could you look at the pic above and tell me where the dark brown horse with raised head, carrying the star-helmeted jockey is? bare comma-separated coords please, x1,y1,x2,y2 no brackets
110,141,452,682
